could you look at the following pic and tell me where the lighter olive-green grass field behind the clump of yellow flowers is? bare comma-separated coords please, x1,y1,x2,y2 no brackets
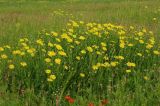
0,0,160,43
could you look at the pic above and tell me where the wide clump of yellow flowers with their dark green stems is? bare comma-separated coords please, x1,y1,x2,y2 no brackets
0,20,160,98
